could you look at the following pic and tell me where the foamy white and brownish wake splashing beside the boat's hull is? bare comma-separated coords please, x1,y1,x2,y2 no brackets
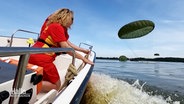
81,73,180,104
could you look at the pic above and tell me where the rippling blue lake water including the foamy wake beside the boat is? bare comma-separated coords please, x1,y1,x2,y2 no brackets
81,59,184,104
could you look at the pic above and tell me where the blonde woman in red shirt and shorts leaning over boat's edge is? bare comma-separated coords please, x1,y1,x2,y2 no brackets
29,8,94,92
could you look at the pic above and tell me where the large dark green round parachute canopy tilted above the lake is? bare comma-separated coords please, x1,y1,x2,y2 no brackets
118,20,155,39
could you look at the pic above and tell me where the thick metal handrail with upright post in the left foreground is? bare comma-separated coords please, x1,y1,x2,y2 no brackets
0,47,75,104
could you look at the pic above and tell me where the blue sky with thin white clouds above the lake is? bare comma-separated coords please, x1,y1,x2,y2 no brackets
0,0,184,58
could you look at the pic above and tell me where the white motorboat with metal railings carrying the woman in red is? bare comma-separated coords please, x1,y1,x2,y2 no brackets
0,29,96,104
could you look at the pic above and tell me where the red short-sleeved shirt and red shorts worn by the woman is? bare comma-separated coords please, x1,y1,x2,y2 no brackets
29,20,69,83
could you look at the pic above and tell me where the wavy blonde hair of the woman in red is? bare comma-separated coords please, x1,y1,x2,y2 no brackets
47,8,73,28
